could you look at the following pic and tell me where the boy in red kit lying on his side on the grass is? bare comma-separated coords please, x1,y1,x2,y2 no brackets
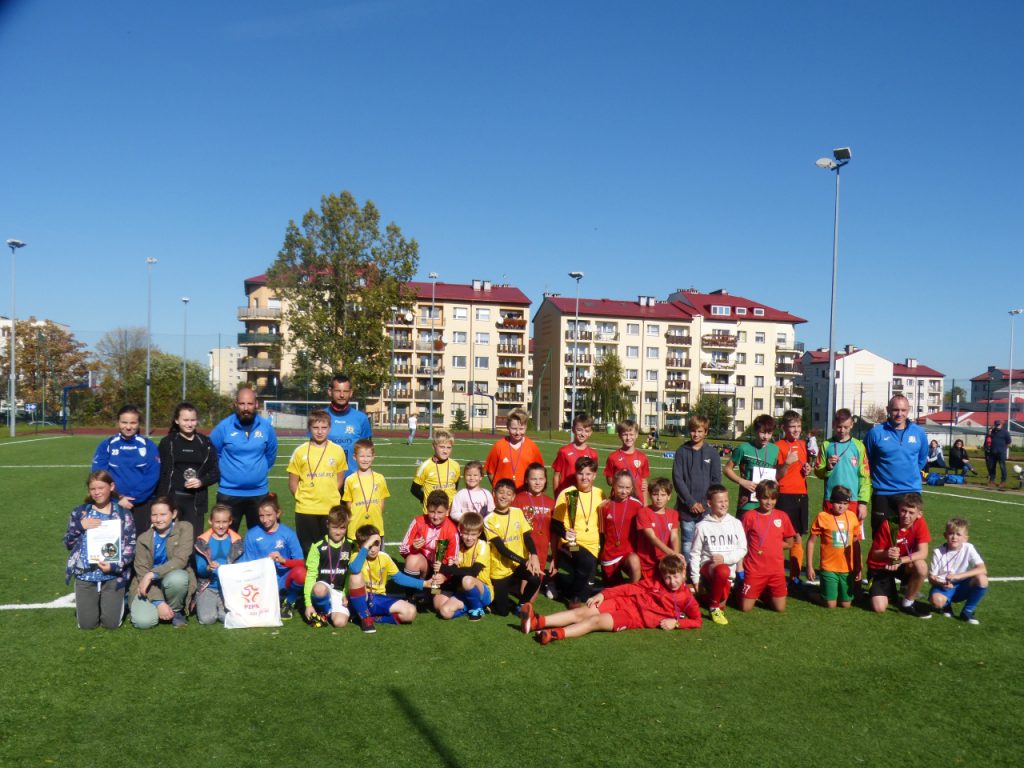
519,554,700,645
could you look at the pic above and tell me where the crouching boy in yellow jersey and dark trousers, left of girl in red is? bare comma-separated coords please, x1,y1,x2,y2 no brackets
483,477,544,616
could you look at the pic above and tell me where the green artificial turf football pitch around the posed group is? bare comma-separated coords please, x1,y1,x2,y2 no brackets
0,435,1024,768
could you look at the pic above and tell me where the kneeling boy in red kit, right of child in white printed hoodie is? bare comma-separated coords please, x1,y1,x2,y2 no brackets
740,480,800,613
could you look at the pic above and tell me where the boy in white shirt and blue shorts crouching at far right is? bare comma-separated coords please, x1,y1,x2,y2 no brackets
928,517,988,624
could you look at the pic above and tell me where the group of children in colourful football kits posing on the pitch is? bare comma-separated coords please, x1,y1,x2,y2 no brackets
65,411,987,644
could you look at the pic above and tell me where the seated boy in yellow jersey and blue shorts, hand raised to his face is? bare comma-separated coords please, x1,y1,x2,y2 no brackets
348,525,434,634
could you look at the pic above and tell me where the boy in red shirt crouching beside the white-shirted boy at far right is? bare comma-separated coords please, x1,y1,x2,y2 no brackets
867,494,932,618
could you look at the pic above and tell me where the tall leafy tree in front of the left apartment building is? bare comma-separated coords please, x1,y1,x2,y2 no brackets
267,191,419,398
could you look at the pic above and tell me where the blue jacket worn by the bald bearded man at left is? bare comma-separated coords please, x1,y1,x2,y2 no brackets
210,414,278,496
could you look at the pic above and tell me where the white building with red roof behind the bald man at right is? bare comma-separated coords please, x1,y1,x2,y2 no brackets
802,345,943,428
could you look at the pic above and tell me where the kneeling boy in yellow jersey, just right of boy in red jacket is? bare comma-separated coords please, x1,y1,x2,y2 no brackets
434,512,492,622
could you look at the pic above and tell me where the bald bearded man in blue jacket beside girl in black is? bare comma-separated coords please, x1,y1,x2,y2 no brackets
210,387,278,530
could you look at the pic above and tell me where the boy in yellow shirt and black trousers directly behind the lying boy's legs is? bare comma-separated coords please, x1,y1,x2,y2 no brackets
551,456,604,607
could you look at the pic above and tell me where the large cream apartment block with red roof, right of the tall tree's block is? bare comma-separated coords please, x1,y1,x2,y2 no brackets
534,289,805,434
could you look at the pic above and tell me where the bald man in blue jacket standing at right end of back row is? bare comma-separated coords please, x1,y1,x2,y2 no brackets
864,394,928,534
